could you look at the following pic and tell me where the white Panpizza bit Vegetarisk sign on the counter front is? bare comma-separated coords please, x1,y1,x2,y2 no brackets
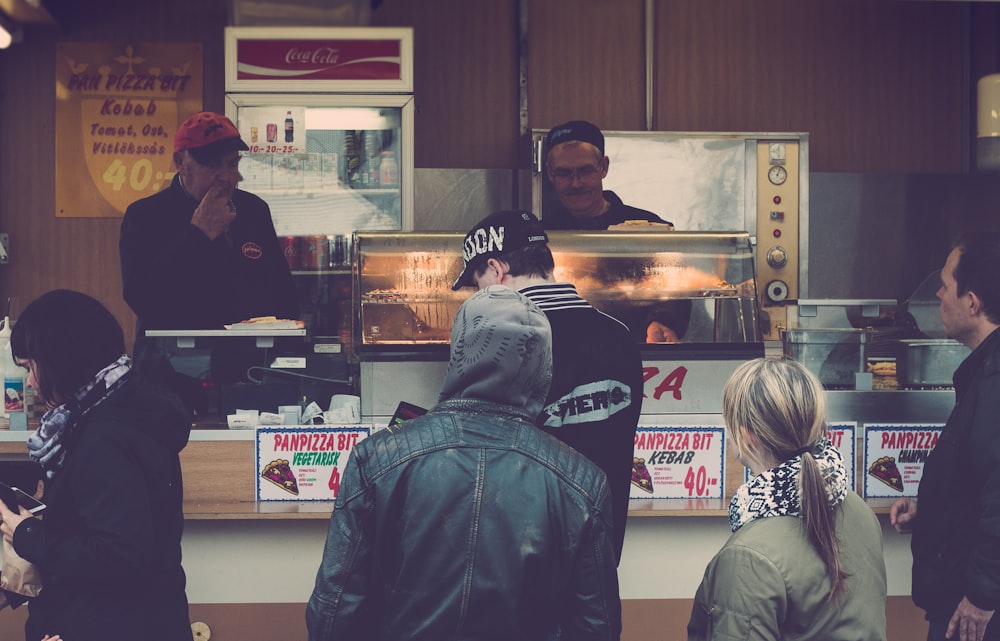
257,426,368,501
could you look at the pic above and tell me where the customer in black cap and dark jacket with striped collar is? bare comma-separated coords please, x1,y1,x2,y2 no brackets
452,211,642,560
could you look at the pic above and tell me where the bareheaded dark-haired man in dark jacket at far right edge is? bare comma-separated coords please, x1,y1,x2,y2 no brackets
890,232,1000,641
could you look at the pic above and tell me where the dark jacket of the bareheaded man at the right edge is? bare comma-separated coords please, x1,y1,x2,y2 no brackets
911,330,1000,616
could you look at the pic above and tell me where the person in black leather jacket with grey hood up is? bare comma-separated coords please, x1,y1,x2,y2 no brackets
306,286,621,641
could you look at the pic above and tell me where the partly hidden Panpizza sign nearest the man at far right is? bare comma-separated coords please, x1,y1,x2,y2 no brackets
864,424,944,499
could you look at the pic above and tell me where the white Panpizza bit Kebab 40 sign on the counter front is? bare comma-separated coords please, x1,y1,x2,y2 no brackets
630,427,725,499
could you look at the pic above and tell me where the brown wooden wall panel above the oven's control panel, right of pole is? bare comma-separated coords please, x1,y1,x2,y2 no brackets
656,0,971,172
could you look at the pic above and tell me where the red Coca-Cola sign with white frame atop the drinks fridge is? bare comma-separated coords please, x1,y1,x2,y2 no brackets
226,27,413,93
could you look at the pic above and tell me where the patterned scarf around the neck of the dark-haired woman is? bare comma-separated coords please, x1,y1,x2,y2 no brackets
28,354,132,480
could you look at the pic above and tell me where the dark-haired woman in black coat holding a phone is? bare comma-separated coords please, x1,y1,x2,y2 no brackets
0,290,191,641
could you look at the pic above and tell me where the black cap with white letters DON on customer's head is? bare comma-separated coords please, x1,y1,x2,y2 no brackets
451,209,549,290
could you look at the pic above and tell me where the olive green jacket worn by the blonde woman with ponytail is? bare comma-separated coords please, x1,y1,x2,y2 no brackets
688,492,886,641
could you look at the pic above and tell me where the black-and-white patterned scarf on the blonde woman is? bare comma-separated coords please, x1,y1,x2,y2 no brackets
729,436,847,532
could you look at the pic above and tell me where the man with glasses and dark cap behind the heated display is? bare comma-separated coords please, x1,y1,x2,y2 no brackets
542,120,666,229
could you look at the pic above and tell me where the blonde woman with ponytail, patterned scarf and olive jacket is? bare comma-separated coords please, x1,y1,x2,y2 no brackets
688,358,886,641
